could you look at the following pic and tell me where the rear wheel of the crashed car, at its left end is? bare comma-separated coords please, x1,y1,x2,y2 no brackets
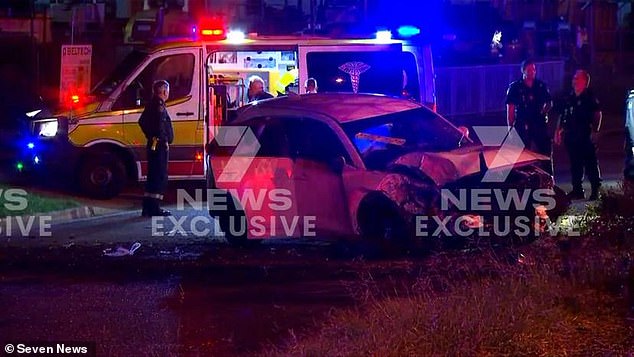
209,193,261,247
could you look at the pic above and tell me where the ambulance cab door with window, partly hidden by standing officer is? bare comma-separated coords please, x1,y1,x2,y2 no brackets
112,48,204,179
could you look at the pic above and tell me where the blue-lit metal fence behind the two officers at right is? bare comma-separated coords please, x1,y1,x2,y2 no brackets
436,60,565,117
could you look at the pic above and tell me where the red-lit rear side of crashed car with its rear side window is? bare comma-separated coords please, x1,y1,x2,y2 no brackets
210,117,302,239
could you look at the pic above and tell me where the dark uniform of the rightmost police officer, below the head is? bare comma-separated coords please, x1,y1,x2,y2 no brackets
560,89,601,196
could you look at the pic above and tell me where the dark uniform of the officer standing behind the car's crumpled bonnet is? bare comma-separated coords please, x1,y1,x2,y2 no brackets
506,79,553,174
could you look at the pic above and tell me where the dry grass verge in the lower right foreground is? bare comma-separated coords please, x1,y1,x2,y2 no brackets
262,182,634,356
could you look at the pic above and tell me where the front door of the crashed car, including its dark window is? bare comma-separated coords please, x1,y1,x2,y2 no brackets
289,118,352,236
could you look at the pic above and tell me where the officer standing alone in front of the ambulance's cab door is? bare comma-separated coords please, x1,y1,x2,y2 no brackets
139,80,174,217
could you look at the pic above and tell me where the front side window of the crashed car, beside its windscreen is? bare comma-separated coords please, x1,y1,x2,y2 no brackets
289,118,352,164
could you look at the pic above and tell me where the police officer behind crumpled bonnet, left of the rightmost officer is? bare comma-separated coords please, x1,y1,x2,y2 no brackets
506,60,553,175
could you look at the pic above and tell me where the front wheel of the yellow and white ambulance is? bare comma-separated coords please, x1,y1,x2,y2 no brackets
79,153,126,199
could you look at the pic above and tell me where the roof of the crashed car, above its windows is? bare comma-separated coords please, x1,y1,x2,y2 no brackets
236,93,423,124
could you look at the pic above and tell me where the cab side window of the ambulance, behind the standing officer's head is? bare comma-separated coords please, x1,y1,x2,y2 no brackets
112,53,195,110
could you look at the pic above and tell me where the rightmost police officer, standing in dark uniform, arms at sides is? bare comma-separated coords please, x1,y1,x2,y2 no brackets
555,70,602,200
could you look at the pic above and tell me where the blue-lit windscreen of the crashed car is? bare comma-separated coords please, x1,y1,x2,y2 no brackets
342,108,471,164
